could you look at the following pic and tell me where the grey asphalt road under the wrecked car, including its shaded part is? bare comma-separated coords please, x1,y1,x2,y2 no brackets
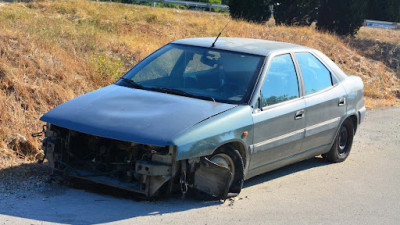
0,107,400,225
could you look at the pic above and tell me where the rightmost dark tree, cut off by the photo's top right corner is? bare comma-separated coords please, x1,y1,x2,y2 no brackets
367,0,400,22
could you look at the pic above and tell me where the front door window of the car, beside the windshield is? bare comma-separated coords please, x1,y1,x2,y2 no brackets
261,54,299,107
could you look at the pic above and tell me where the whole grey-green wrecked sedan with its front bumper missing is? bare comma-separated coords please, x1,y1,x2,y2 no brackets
37,38,366,199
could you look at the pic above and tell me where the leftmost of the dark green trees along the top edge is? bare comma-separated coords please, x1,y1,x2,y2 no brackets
228,0,272,23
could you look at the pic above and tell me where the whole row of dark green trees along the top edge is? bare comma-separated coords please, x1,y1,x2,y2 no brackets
228,0,400,35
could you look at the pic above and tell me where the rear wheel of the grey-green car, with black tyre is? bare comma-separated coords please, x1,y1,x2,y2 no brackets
326,119,354,162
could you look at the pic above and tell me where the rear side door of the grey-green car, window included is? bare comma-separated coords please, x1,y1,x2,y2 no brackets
295,52,346,154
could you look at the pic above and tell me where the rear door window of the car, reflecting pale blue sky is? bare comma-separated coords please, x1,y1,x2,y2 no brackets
295,52,332,94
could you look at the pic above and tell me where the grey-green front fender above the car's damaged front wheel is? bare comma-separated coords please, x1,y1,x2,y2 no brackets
173,106,253,160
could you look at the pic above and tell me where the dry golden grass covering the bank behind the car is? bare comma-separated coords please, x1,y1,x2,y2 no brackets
0,0,400,167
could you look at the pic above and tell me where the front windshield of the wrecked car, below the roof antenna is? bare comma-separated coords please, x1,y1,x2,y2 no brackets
117,44,264,103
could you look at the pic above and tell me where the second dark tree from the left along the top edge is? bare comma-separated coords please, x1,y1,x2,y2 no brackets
274,0,320,26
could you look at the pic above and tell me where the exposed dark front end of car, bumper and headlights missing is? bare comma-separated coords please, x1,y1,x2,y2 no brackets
43,124,178,197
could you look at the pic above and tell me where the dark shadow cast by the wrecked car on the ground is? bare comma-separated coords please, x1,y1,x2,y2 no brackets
0,158,328,224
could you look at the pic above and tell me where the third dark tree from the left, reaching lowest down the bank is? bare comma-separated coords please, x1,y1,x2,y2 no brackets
317,0,367,36
